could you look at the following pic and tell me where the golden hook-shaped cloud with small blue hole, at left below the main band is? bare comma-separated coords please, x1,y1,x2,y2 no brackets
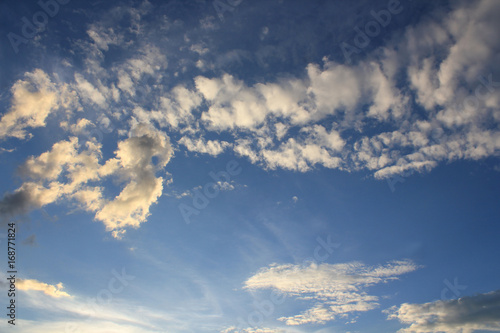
0,124,172,238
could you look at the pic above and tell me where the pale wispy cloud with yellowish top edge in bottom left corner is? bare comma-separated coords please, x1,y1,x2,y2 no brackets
0,274,172,333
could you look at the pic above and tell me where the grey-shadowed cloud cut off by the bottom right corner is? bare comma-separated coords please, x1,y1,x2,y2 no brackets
385,290,500,333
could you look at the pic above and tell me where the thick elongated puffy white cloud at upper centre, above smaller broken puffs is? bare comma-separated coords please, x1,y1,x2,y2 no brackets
194,59,405,130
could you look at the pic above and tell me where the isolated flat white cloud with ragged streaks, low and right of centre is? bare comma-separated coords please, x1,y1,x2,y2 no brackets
245,260,418,325
